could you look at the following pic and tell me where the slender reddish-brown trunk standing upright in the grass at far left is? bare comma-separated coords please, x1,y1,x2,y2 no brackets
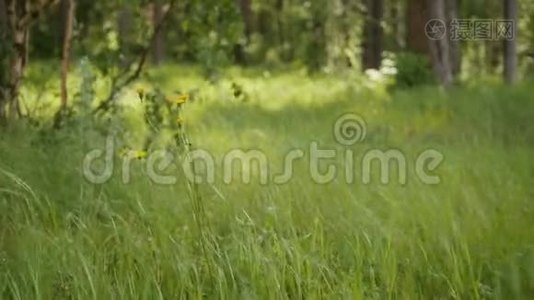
61,0,76,111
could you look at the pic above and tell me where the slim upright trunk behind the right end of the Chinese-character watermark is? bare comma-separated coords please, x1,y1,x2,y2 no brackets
504,0,519,84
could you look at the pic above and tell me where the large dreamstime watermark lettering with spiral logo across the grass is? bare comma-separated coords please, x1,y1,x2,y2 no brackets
82,113,444,185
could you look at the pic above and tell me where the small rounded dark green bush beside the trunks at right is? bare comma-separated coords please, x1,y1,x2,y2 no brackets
395,52,435,88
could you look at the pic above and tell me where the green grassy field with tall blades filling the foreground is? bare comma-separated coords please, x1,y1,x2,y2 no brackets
0,67,534,299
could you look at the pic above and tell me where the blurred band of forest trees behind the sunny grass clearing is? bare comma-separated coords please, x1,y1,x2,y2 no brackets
0,0,534,125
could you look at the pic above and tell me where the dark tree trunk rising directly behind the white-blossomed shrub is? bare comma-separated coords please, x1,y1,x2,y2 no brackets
362,0,384,71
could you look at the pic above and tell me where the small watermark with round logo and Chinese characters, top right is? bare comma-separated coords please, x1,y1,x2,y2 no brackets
425,19,517,41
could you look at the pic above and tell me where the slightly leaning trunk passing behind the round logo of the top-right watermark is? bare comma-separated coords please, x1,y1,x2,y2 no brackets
428,0,453,87
